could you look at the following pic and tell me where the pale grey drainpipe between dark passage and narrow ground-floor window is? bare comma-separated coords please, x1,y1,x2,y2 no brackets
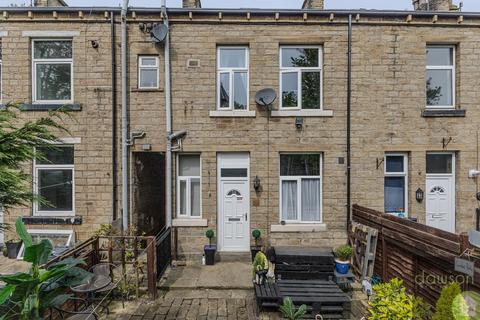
162,0,172,228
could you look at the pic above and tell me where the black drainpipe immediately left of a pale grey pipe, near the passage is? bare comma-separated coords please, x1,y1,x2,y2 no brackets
110,11,117,221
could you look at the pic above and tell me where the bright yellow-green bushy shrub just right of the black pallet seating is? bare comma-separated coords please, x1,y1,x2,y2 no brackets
368,278,414,320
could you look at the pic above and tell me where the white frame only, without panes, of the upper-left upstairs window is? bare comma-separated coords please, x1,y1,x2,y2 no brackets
32,38,74,104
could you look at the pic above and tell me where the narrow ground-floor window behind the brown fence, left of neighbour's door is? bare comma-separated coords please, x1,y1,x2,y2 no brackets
384,154,408,216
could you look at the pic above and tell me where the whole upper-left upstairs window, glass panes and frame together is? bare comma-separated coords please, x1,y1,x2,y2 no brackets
32,40,73,103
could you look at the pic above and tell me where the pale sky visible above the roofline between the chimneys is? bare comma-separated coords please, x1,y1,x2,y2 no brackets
5,0,480,12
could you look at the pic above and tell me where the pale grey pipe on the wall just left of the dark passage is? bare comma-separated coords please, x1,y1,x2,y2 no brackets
121,0,129,232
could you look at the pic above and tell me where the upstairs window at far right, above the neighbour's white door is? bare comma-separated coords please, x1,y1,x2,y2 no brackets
426,45,455,108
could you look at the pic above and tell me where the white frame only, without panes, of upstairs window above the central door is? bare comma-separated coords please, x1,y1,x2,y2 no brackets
217,46,250,112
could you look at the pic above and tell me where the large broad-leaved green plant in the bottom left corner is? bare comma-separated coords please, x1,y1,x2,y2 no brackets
0,218,93,320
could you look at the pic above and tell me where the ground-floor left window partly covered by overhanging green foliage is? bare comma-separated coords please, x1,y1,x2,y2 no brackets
34,146,75,216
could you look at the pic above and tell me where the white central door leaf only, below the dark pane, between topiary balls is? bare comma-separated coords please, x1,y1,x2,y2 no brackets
221,180,250,251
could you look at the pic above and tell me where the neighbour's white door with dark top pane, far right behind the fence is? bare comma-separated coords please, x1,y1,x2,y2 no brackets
425,153,455,232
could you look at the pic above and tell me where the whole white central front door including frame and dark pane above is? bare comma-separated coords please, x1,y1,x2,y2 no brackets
218,153,250,252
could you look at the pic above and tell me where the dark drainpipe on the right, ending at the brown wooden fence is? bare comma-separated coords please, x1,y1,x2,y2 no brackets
347,14,352,232
